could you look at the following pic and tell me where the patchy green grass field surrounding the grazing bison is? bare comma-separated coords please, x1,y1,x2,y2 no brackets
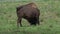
0,0,60,34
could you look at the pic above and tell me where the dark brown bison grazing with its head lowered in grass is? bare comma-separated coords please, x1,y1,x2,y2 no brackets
17,3,40,27
